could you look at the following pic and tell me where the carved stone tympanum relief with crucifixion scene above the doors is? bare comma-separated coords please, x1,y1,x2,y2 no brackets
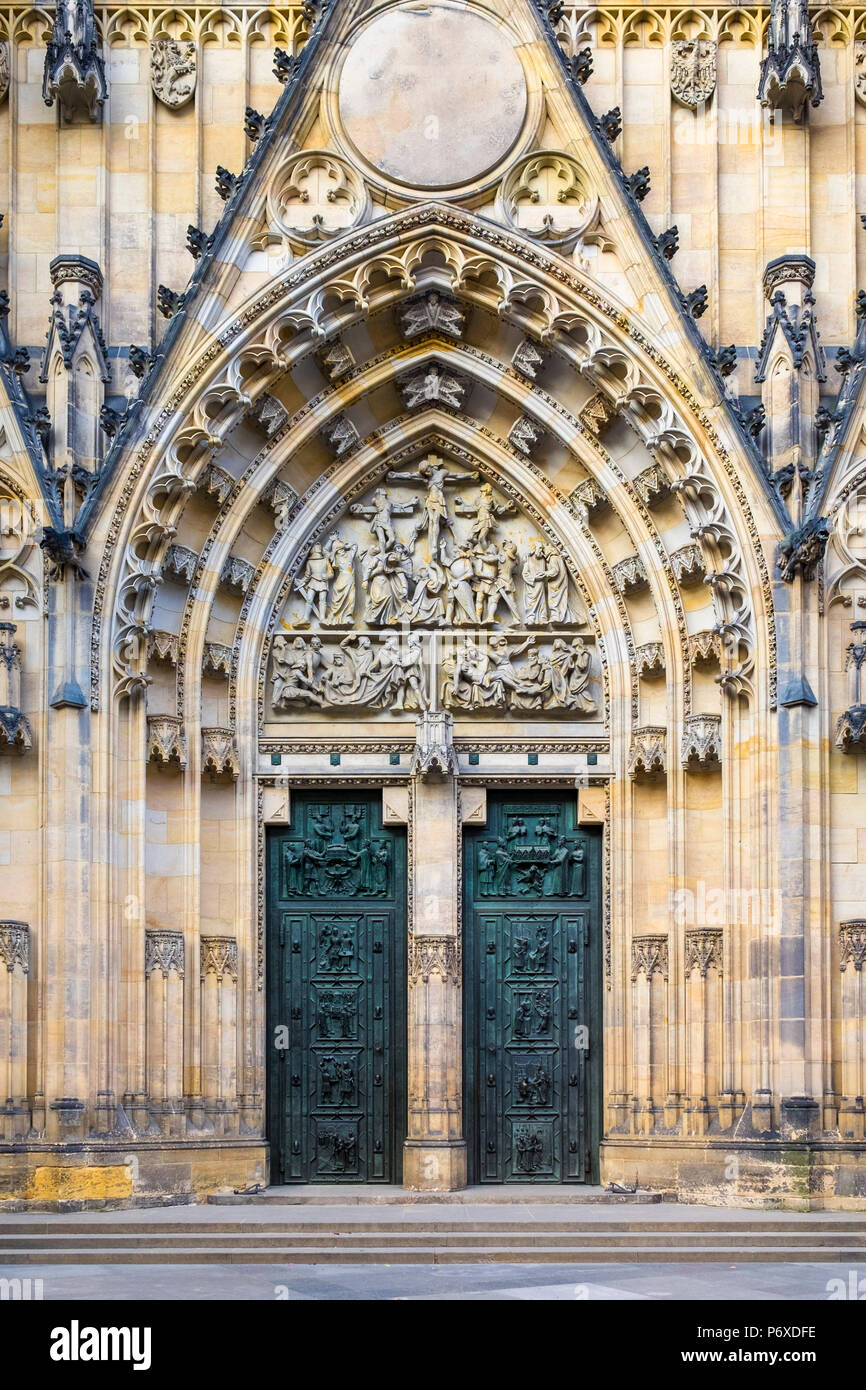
268,455,599,720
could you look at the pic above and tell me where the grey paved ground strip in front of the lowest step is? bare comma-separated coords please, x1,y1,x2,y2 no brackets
0,1264,866,1302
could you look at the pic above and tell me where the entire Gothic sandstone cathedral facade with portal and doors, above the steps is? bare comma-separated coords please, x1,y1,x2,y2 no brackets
0,0,866,1209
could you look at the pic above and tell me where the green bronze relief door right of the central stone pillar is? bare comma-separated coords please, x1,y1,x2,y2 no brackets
464,792,602,1183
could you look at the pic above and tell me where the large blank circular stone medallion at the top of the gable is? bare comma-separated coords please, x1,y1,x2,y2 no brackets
339,6,527,188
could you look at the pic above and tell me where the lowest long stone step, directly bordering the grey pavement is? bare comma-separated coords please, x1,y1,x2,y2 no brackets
3,1241,851,1268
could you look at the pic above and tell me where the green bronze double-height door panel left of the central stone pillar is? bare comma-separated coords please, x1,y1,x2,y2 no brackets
268,792,406,1183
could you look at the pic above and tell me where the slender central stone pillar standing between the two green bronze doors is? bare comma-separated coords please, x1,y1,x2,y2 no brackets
403,712,466,1191
